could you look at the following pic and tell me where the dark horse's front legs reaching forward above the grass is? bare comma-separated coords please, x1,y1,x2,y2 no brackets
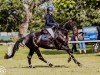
62,45,82,66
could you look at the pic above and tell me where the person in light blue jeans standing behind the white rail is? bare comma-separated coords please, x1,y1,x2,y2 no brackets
78,32,86,53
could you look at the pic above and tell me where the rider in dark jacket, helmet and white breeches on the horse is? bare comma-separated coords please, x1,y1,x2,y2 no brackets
45,7,58,38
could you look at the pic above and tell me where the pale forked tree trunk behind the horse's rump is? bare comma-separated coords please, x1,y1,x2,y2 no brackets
19,0,49,37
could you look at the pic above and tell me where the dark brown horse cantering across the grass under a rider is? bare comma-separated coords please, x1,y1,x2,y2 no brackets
4,22,82,68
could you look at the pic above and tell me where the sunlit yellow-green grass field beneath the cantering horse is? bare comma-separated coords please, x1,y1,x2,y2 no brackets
0,46,100,75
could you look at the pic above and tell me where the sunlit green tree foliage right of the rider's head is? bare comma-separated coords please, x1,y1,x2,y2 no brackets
54,0,100,26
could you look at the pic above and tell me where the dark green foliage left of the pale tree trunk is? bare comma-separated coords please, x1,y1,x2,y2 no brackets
0,0,25,31
